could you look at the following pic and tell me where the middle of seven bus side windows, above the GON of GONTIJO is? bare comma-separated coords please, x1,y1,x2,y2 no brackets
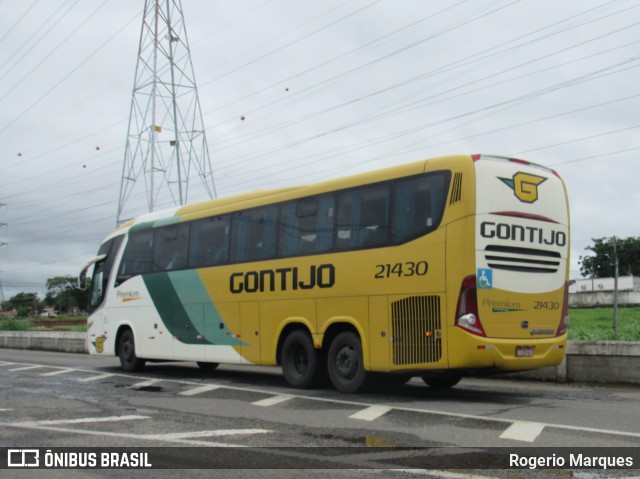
231,205,278,262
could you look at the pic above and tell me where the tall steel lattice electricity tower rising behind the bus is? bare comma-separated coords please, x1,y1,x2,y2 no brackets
116,0,216,224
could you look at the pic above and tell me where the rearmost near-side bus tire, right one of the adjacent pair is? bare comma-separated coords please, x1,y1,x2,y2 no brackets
327,331,367,394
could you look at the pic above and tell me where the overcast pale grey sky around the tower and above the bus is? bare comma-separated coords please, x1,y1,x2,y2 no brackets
0,0,640,299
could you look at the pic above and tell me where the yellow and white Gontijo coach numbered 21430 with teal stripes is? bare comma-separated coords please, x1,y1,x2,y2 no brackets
80,155,569,393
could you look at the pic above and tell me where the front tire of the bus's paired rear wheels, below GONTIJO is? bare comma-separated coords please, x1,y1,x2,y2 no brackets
280,329,318,389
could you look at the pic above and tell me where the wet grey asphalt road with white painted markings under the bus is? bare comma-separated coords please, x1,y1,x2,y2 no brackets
0,350,640,479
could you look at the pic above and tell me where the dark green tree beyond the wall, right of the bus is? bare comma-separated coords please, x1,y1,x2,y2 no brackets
578,236,640,278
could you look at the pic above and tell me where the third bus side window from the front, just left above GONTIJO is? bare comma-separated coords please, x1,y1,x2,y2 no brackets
189,216,230,268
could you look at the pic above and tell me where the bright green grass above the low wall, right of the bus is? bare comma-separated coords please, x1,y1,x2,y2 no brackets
569,307,640,341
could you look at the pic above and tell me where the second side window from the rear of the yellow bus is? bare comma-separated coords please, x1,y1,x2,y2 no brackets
336,184,390,249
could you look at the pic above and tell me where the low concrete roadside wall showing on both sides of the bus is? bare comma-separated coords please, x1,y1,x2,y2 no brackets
0,331,640,385
